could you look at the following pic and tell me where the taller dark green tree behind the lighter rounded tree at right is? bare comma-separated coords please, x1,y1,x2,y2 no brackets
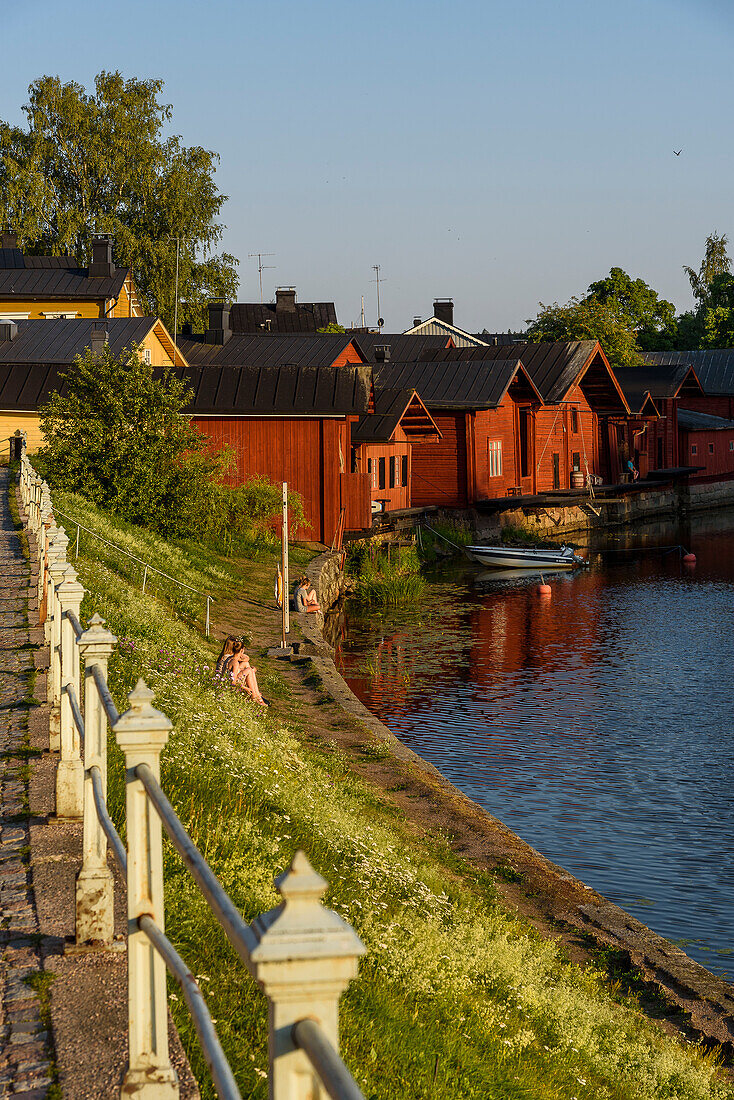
588,267,677,351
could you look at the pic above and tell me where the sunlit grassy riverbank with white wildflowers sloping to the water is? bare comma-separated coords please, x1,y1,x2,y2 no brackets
57,494,734,1100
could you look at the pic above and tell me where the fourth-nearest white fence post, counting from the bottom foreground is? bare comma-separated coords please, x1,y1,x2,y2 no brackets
56,565,84,817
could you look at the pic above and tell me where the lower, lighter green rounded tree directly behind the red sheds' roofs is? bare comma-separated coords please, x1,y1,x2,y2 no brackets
527,296,640,366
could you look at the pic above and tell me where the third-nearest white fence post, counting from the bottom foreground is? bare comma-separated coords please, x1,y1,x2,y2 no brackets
76,612,117,945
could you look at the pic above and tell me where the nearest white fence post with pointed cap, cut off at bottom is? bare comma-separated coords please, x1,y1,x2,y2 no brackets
251,851,365,1100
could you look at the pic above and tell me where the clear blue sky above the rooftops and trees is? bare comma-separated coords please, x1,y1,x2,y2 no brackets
0,0,734,330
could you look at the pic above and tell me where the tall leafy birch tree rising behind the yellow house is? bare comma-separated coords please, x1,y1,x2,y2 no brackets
0,73,237,329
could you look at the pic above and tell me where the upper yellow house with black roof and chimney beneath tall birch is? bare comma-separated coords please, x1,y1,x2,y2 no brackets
0,233,143,322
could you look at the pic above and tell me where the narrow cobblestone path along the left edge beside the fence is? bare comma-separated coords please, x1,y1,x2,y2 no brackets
0,466,51,1100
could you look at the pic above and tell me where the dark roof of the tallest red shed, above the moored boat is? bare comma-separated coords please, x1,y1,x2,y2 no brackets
424,340,599,405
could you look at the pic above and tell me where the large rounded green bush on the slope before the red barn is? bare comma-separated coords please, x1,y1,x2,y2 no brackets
40,344,304,536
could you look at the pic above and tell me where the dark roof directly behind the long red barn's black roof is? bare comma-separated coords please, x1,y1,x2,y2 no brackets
178,332,365,366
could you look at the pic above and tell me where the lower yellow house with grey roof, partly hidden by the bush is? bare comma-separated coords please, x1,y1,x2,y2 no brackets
0,317,188,454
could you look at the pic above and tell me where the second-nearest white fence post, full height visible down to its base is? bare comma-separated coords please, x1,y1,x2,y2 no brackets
114,680,178,1100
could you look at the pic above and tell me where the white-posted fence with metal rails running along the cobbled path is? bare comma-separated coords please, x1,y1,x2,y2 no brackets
20,452,364,1100
